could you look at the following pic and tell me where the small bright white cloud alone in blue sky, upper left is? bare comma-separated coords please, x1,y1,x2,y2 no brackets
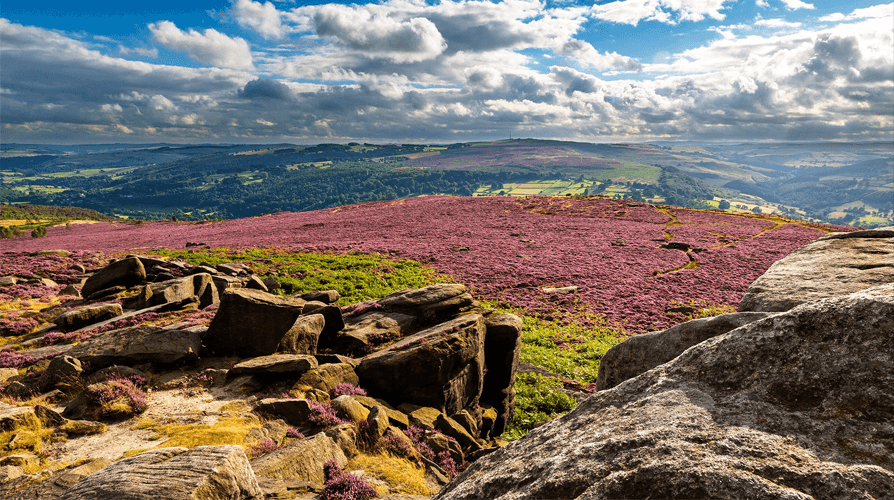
149,21,254,70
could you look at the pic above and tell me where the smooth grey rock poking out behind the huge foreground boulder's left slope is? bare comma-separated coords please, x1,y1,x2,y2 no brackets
596,312,770,391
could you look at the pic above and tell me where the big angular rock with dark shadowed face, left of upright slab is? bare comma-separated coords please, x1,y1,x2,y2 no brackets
357,314,485,414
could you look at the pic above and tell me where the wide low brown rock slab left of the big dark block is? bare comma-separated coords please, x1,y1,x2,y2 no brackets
68,325,202,367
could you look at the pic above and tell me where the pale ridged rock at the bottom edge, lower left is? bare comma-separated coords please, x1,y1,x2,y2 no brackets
60,446,262,500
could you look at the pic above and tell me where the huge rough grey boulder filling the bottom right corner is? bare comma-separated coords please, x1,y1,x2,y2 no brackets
436,285,894,500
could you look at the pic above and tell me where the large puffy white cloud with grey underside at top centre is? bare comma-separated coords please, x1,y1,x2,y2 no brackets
314,4,447,62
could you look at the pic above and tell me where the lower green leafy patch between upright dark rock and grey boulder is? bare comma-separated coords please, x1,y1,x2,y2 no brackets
503,373,577,441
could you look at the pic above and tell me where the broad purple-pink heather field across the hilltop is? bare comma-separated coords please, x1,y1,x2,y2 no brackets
0,196,853,333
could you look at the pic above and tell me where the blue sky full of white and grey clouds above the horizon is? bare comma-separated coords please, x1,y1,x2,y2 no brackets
0,0,894,144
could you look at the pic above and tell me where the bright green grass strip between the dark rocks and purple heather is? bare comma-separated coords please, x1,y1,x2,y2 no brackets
153,248,452,305
